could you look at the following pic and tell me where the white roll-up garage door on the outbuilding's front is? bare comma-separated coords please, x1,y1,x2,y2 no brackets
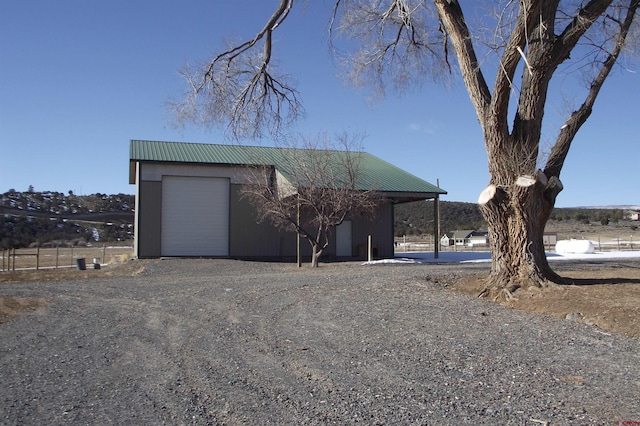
161,176,229,256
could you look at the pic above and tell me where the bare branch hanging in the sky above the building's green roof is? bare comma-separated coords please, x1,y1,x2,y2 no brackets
169,0,303,138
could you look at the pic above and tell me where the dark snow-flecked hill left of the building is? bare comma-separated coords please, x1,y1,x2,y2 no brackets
0,190,134,249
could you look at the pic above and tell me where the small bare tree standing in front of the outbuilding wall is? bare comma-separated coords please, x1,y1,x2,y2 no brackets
241,134,378,267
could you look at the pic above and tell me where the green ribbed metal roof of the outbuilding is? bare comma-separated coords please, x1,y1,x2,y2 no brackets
129,140,447,198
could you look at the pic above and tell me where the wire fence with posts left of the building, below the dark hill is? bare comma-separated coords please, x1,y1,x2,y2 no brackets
1,244,133,272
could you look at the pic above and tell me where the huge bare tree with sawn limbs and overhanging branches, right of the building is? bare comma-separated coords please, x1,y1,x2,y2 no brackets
172,0,640,297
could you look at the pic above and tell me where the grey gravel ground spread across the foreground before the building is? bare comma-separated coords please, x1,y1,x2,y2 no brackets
0,260,640,425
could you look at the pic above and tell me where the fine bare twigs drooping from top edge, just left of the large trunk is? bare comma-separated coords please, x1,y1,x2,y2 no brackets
329,0,447,98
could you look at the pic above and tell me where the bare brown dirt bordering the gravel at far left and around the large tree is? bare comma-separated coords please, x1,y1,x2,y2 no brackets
0,256,640,338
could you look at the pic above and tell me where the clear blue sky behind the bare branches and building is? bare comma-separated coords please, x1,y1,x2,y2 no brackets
0,0,640,207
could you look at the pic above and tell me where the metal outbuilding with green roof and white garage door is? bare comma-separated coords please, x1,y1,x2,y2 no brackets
129,140,446,258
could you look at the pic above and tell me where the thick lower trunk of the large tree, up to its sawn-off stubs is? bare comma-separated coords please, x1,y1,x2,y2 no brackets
478,171,563,298
